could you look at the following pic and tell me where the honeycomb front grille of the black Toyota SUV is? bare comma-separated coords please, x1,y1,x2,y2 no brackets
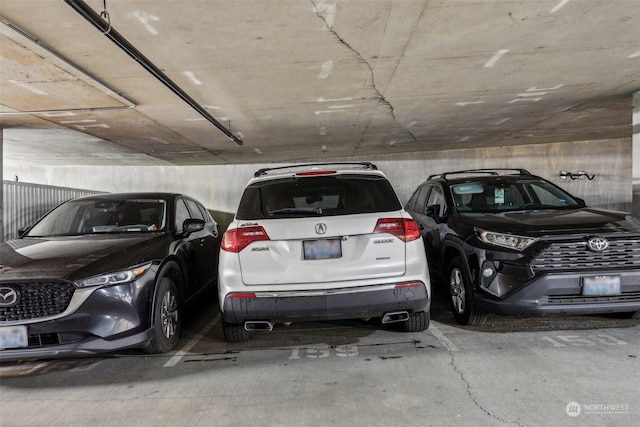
531,240,640,273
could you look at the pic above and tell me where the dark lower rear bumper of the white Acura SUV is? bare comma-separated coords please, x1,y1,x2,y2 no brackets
222,282,431,324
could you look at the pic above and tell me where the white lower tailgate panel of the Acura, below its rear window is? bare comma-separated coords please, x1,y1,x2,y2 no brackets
239,216,405,286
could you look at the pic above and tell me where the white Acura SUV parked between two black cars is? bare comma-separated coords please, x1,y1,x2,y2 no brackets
218,163,431,342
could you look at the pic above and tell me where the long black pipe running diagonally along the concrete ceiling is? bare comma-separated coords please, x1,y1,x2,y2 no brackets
63,0,244,145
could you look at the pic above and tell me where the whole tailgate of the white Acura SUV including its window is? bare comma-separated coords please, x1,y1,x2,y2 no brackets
239,172,408,287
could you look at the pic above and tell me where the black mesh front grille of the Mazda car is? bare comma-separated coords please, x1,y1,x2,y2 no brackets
0,282,75,322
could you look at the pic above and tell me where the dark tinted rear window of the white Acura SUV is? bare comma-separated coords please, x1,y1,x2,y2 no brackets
237,174,402,220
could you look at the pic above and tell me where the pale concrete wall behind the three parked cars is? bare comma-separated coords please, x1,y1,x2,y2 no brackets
4,138,633,231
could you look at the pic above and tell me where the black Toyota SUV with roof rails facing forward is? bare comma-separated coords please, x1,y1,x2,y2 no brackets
406,169,640,325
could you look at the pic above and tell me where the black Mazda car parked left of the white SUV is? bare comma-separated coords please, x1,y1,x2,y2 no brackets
0,193,220,360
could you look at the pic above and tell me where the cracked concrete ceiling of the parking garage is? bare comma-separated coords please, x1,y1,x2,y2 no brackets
0,0,640,165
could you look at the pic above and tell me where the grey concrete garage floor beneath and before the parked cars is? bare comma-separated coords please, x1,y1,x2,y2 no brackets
0,294,640,427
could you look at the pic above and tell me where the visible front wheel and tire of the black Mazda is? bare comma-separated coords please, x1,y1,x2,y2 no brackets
144,276,182,354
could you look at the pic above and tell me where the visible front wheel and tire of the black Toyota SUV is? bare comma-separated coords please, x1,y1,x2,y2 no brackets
447,257,487,325
